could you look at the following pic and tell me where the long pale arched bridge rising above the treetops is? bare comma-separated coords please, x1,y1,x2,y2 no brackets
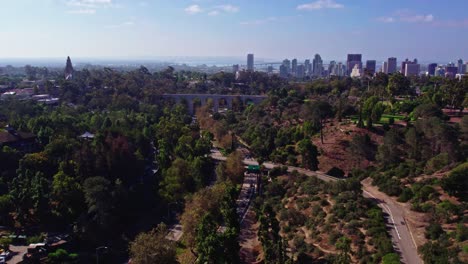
162,94,267,115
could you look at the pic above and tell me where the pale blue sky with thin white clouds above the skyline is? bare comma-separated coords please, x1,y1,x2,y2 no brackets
0,0,468,62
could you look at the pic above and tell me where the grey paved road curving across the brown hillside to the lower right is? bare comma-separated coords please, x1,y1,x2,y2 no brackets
211,150,423,264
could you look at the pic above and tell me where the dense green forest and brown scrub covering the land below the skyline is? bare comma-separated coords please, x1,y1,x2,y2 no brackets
0,67,468,263
